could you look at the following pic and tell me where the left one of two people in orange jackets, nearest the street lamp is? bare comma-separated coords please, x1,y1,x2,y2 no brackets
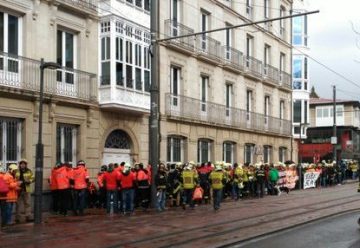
54,163,71,216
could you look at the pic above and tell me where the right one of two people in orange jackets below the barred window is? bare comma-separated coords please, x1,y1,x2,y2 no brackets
71,160,89,215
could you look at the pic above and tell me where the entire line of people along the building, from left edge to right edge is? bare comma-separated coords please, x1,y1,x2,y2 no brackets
0,159,358,226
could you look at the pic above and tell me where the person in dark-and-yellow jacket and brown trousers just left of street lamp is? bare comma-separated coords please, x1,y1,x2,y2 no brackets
15,159,35,223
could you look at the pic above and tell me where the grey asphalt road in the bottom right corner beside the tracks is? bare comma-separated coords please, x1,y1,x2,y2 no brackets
232,212,360,248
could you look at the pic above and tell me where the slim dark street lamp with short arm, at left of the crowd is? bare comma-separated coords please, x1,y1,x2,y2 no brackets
34,59,61,224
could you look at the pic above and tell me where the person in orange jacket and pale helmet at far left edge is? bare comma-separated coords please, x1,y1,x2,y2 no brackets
0,164,20,226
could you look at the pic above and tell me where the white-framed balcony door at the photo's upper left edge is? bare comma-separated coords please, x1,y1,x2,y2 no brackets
0,12,22,88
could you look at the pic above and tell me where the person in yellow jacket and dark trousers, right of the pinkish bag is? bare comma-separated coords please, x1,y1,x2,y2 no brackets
209,165,226,211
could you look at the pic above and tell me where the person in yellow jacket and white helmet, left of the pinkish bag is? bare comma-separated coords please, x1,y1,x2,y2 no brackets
180,162,198,210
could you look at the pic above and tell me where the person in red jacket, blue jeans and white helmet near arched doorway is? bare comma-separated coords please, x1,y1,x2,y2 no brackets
119,164,136,215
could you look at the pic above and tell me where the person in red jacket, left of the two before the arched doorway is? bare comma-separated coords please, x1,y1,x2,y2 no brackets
103,164,119,214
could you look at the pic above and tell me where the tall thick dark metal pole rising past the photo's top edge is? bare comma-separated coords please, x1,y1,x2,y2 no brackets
149,0,160,207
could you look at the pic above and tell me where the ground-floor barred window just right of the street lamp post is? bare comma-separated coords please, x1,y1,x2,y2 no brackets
56,124,77,165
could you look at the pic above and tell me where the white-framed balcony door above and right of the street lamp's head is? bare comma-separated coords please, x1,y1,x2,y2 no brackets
56,30,77,97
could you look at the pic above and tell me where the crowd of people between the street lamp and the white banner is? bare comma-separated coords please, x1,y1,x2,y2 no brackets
49,161,298,215
